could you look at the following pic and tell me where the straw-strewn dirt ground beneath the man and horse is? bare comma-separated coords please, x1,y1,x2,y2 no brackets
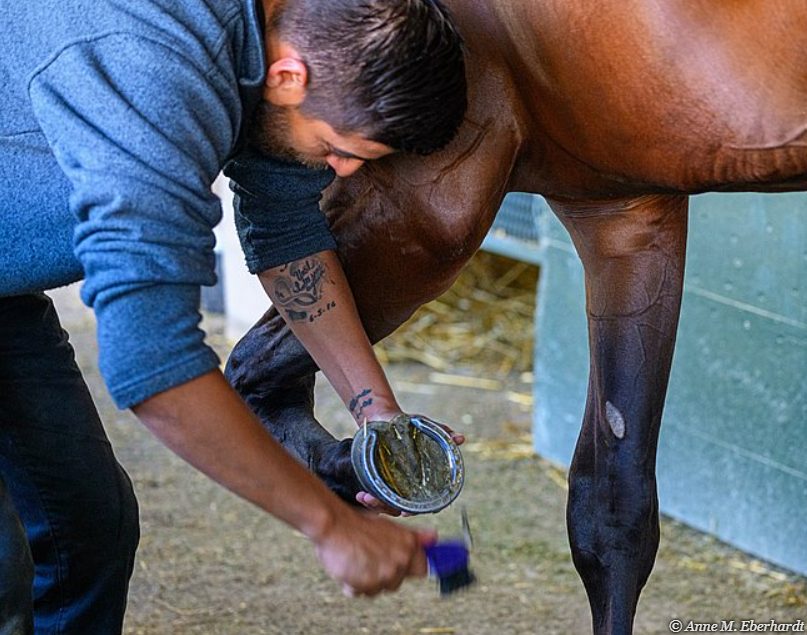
47,287,807,635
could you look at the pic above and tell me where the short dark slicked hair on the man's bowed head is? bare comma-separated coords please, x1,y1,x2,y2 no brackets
276,0,467,154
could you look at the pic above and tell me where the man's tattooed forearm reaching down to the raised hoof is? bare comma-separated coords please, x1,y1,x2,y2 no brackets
260,251,400,424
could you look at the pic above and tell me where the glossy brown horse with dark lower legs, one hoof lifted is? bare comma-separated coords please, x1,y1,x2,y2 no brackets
227,0,807,635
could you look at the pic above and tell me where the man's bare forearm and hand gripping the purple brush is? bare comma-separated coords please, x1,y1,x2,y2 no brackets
133,371,435,595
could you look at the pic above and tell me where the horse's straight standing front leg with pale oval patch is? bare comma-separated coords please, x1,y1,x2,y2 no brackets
553,196,687,635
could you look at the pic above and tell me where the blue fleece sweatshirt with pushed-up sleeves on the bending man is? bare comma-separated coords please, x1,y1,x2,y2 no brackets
0,0,335,408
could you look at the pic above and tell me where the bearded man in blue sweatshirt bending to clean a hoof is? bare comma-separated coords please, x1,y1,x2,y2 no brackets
0,0,465,634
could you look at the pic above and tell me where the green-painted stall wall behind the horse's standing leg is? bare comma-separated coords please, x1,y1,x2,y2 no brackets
535,194,807,573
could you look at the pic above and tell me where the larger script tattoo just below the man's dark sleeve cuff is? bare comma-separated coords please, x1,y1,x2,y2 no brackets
274,255,336,322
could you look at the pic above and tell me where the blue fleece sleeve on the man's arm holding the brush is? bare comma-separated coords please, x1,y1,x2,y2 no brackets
29,33,241,408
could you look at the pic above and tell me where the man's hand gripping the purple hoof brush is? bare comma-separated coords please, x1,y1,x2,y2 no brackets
315,510,437,596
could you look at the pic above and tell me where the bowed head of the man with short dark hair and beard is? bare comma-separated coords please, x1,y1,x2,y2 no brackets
255,0,467,176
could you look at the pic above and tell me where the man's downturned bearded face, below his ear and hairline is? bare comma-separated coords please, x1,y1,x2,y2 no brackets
250,101,394,178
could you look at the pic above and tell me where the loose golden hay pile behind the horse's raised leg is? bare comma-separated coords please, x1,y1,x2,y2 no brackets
376,251,538,377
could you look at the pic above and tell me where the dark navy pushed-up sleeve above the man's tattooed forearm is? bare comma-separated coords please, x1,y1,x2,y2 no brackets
224,149,336,274
